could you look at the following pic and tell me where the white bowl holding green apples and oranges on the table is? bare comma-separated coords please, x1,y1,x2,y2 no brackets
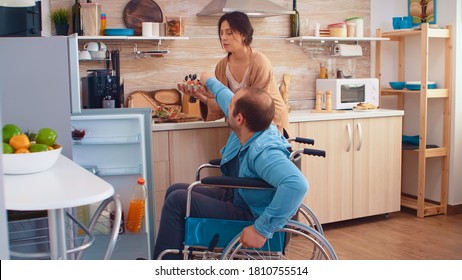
2,147,63,175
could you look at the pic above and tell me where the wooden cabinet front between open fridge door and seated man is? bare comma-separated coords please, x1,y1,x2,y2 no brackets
152,127,230,230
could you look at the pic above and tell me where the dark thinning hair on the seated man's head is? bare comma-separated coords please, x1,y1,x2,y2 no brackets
233,88,275,132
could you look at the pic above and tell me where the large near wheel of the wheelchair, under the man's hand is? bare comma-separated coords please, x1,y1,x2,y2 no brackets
221,221,338,260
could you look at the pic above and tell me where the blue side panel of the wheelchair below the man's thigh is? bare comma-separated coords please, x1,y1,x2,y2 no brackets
185,217,284,251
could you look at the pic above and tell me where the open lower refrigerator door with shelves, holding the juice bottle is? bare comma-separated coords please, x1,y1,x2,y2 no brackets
71,108,156,260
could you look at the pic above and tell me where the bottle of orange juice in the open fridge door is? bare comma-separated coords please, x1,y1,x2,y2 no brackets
125,178,146,233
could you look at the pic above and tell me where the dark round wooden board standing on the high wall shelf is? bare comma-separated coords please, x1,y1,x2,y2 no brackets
123,0,164,36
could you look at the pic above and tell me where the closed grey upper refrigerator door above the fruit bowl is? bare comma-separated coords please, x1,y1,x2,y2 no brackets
0,36,80,158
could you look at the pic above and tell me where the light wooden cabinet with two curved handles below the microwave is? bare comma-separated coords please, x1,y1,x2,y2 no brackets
298,117,402,223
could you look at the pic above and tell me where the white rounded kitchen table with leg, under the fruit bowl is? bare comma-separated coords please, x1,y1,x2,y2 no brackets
4,155,114,259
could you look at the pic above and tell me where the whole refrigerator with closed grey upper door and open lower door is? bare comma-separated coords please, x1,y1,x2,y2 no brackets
0,36,156,259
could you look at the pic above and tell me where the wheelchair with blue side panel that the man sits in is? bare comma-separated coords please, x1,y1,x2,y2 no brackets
158,137,338,260
